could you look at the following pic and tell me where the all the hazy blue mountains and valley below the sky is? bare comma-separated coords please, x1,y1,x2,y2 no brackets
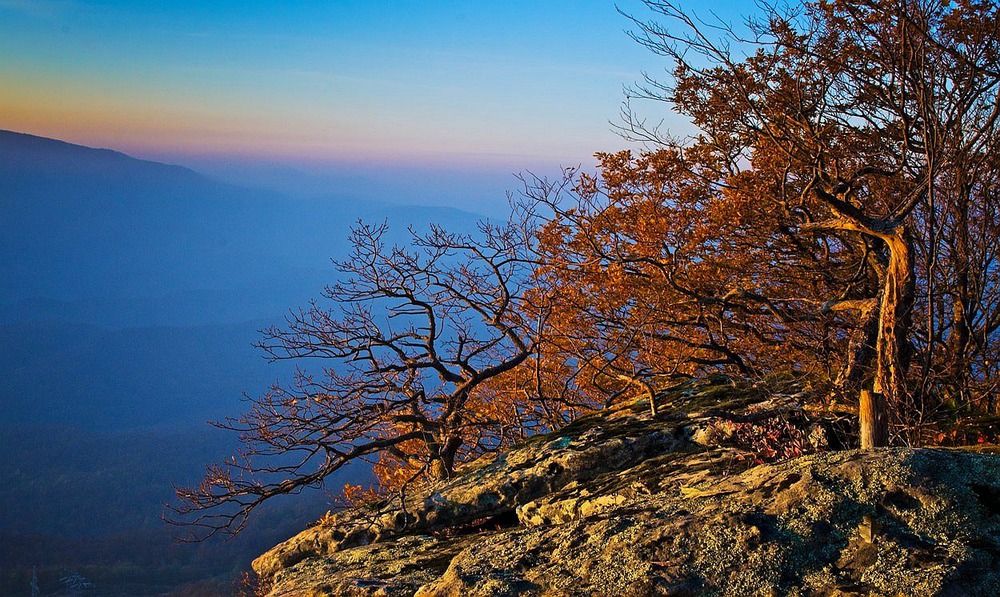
0,131,484,595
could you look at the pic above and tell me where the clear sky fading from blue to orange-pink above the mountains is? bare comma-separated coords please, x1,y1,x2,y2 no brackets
0,0,736,210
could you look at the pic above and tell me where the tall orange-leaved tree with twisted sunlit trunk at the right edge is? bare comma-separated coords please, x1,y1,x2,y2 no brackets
562,0,1000,444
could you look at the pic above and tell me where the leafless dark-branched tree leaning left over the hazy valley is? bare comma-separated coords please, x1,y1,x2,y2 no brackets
176,213,559,538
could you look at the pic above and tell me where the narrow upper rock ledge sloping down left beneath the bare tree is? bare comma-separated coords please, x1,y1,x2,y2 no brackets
253,396,700,577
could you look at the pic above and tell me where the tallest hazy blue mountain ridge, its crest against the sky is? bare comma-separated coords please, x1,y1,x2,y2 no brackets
0,131,476,325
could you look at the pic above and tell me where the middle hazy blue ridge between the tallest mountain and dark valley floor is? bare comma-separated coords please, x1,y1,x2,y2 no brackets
0,322,278,430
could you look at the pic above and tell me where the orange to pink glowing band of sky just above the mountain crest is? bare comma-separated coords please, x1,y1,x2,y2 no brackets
0,79,589,168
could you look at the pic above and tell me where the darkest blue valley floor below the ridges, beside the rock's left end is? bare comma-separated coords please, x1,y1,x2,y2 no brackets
0,426,364,595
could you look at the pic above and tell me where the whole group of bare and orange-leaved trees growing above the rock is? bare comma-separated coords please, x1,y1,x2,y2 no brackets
181,0,1000,529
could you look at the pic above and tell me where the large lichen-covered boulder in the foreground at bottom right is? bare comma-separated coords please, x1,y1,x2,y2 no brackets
420,449,1000,595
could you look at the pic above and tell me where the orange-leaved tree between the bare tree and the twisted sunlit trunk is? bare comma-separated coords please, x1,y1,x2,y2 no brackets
528,150,853,415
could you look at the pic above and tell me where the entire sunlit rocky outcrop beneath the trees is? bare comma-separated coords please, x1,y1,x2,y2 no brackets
254,382,1000,596
